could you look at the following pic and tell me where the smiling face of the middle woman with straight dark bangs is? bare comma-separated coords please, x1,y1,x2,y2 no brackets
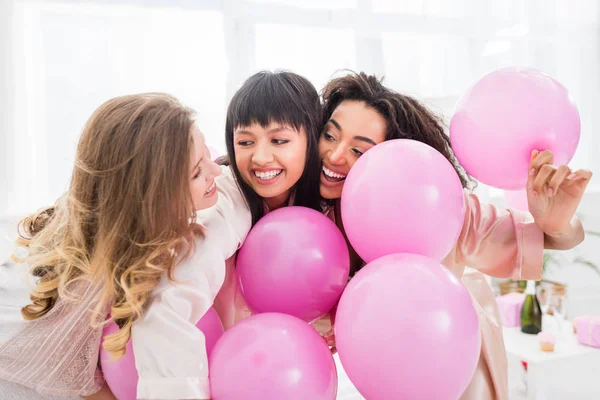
234,122,308,209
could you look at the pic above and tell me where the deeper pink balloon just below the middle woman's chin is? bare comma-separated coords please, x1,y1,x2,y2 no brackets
237,207,350,322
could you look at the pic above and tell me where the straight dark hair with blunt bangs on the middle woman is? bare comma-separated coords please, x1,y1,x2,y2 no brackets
225,71,322,224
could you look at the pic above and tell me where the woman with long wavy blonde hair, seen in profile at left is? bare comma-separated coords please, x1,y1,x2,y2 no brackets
0,93,251,400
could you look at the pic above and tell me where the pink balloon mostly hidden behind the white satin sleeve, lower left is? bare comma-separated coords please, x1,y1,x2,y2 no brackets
100,307,224,400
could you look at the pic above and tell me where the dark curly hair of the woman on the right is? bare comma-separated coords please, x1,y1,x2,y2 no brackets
321,72,475,189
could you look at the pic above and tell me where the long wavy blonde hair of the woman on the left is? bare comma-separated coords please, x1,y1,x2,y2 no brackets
18,93,195,358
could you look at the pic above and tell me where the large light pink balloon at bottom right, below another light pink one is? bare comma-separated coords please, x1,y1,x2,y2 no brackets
335,254,481,400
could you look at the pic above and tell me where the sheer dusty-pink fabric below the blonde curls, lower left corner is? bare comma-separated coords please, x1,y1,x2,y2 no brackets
0,281,104,396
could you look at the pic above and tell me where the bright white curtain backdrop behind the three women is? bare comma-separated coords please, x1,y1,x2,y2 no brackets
0,0,600,220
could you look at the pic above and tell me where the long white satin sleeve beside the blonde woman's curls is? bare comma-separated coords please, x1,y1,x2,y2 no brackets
132,167,251,399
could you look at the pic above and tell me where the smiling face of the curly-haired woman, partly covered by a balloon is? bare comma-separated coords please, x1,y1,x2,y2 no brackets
319,101,387,199
